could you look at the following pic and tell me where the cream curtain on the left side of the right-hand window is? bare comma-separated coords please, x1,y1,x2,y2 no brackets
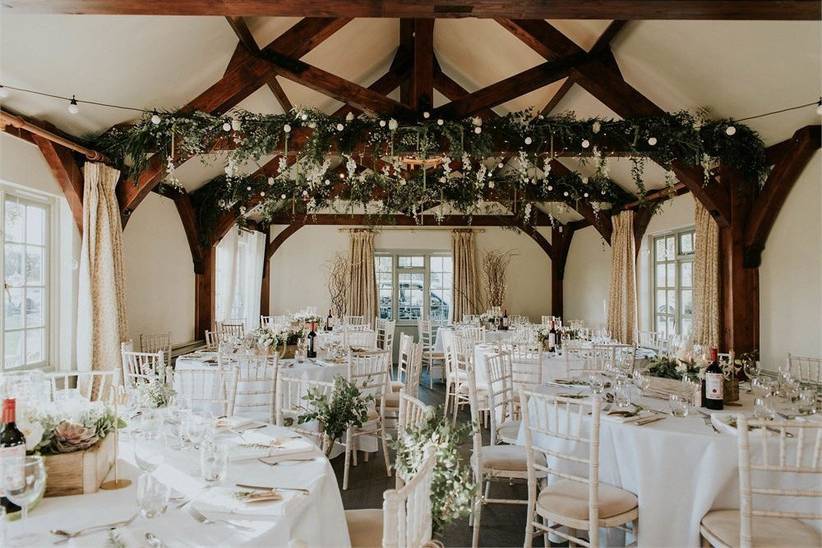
608,211,637,344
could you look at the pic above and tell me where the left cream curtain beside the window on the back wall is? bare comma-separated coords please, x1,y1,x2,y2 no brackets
345,228,377,322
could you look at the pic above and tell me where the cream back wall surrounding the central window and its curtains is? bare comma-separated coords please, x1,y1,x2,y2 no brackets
270,226,551,320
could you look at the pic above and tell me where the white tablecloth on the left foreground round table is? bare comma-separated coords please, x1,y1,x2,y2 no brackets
19,426,350,548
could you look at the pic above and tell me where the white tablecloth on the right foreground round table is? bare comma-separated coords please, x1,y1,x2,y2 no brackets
518,386,820,547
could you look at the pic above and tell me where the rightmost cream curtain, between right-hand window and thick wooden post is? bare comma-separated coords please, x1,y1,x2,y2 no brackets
692,200,719,346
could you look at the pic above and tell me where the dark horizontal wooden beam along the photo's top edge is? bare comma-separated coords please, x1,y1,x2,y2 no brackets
9,0,822,21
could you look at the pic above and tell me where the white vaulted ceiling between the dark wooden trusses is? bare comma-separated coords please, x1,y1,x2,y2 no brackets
0,15,822,195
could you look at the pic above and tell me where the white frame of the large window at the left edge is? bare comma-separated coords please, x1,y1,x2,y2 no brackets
0,181,60,372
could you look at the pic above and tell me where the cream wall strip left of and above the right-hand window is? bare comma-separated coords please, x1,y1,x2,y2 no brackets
637,193,694,331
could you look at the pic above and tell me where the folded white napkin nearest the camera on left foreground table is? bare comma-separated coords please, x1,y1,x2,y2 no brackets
192,487,300,520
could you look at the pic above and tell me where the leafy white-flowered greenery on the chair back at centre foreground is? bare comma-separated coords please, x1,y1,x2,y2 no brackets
392,409,476,533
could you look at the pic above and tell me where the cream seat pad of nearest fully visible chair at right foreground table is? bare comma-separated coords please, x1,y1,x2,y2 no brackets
537,480,639,520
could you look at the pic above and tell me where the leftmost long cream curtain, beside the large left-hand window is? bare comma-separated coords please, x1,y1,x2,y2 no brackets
77,162,128,371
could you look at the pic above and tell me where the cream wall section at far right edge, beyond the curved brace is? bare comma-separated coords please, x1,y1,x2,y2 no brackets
759,151,822,369
